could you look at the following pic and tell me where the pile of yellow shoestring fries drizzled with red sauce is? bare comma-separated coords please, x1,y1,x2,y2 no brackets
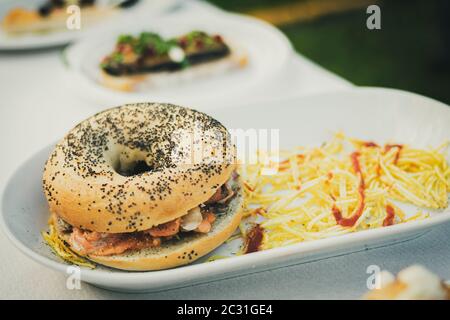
240,133,450,250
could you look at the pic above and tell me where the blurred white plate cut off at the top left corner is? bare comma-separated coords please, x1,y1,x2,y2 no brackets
0,0,179,50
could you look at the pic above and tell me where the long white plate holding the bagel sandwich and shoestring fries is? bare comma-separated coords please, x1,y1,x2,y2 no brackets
2,88,450,292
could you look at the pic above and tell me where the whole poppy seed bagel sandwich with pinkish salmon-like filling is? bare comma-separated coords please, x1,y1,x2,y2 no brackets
43,103,243,271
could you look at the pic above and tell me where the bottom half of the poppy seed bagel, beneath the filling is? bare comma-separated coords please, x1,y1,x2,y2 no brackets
57,184,243,271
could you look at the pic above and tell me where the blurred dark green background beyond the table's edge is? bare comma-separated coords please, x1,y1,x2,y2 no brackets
208,0,450,103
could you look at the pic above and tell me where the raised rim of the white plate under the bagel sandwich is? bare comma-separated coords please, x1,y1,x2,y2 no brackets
0,87,450,286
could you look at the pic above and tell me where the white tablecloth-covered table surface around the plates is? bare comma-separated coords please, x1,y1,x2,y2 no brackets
0,1,450,299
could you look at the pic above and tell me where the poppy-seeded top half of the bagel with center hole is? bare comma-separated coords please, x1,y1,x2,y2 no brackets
43,103,236,233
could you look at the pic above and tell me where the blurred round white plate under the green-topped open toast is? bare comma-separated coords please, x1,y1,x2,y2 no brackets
66,13,293,105
